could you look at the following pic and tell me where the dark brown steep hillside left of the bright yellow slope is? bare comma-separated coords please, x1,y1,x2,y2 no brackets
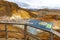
0,1,18,16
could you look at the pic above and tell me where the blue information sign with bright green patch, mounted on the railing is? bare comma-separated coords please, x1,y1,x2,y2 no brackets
28,20,53,31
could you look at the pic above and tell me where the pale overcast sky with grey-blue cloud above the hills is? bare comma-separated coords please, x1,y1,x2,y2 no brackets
5,0,60,9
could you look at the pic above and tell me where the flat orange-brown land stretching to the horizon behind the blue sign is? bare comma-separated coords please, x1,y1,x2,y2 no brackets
30,9,60,29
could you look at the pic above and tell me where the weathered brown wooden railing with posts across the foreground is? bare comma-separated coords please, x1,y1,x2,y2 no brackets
0,20,57,40
